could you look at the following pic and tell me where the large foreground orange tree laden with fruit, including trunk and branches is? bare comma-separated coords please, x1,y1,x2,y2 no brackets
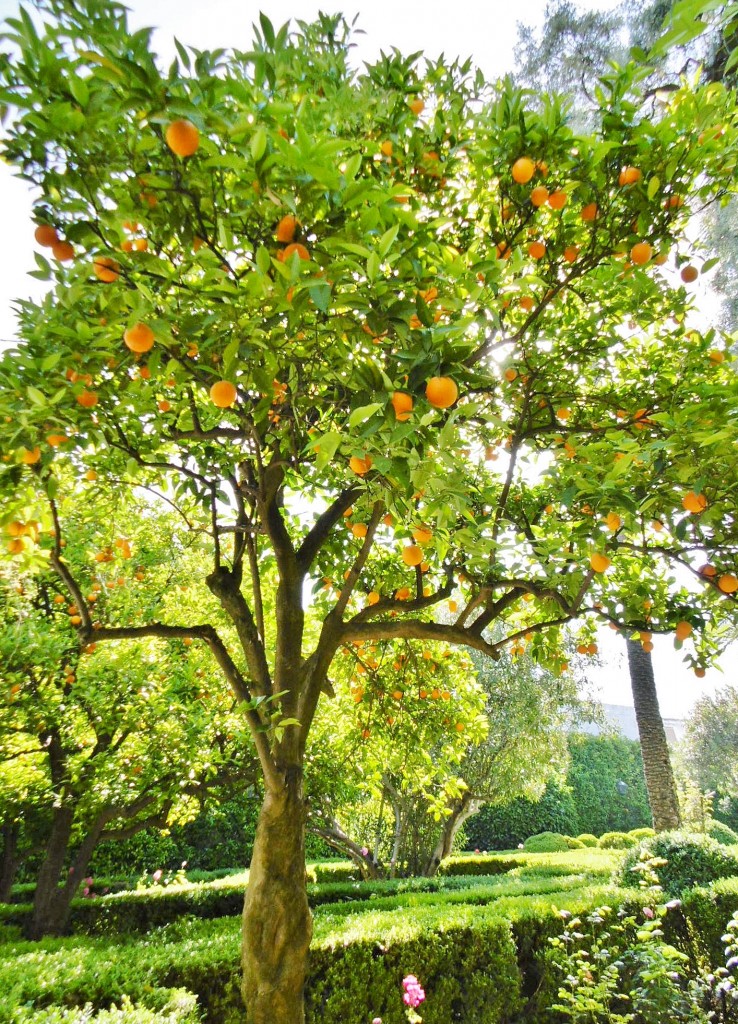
0,0,738,1024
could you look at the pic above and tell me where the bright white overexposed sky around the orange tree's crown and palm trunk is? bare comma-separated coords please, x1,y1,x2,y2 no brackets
0,0,738,718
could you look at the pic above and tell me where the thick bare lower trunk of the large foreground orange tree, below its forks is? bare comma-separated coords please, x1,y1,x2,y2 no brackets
243,765,312,1024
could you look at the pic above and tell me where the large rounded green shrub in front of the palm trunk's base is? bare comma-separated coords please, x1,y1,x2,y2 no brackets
616,831,738,896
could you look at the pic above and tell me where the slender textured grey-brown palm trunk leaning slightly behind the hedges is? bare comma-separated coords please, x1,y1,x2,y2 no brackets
626,640,682,831
